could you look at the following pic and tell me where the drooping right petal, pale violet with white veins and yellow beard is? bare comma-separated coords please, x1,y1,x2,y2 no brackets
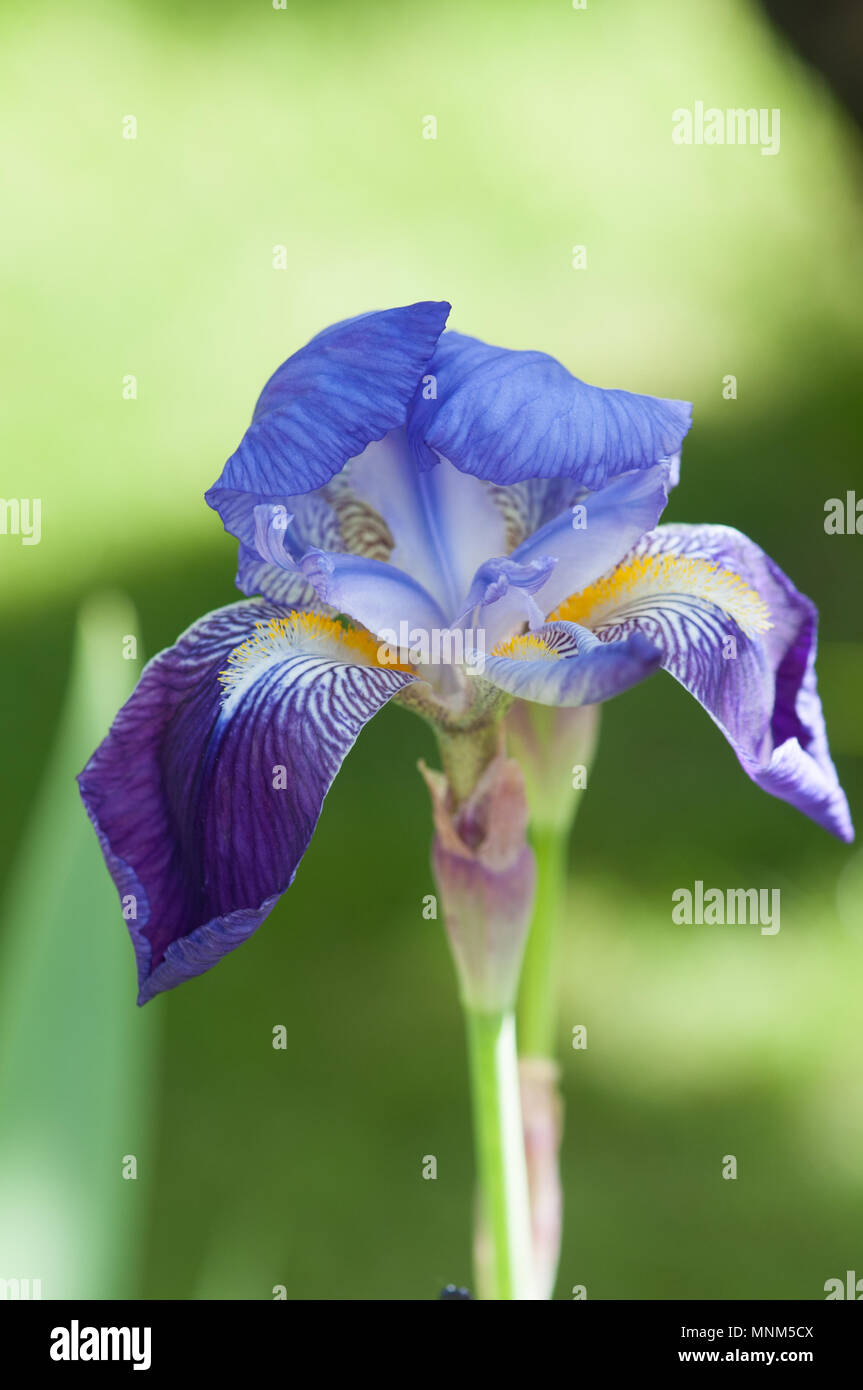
547,525,853,841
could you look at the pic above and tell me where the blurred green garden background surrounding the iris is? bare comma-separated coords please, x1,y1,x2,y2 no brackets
0,0,863,1298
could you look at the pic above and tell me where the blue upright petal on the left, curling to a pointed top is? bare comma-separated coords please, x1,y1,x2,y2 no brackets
207,302,450,545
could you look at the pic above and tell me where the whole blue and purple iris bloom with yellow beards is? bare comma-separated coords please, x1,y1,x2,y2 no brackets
79,303,853,1004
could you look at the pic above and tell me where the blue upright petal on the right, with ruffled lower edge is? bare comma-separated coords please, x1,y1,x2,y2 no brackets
409,332,692,488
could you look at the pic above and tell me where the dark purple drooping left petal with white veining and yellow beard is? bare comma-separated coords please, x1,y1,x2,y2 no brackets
79,602,413,1004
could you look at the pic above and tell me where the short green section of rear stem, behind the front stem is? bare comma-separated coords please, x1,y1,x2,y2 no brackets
518,826,570,1058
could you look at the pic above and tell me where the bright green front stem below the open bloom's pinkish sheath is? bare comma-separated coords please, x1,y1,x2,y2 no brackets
467,1009,534,1300
